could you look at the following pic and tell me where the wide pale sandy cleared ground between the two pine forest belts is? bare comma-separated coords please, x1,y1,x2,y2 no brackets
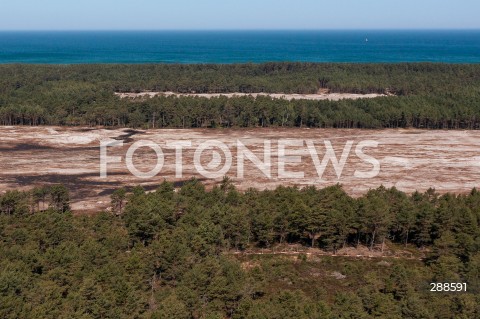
0,127,480,212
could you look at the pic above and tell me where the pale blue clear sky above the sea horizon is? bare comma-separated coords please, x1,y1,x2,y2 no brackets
0,0,480,30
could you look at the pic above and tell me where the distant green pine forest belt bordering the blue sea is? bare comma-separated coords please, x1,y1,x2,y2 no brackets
0,63,480,129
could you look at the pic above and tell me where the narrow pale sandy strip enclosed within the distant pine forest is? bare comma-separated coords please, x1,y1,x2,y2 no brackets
115,92,387,101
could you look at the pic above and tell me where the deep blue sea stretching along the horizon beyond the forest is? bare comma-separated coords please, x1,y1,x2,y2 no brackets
0,30,480,64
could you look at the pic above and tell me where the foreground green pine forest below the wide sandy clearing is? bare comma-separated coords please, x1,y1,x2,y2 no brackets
0,178,480,319
